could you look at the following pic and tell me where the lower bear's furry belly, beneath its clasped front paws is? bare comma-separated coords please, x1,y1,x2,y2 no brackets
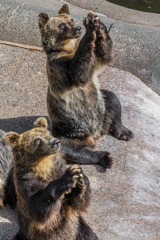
20,206,79,240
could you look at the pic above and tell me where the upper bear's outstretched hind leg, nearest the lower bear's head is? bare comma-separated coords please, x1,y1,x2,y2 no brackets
61,138,112,168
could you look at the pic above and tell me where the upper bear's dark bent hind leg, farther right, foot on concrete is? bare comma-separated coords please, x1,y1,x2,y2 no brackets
101,89,133,141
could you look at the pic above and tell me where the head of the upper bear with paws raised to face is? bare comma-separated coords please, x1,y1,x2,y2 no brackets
38,4,81,53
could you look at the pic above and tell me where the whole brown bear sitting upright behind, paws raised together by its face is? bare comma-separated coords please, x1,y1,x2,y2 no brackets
38,4,133,168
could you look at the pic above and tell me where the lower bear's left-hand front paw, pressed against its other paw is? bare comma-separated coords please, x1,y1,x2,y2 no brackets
63,165,82,194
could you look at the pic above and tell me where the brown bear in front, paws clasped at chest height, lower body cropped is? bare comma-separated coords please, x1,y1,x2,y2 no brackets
5,118,98,240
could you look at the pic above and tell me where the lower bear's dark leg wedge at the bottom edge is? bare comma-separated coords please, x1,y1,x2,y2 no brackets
76,217,98,240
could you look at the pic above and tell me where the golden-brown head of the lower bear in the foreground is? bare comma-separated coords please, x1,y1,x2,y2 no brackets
5,117,60,164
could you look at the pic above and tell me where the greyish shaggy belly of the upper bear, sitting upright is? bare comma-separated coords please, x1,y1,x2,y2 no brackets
47,82,105,138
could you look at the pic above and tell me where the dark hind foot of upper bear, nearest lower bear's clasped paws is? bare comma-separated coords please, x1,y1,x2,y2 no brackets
96,151,113,169
